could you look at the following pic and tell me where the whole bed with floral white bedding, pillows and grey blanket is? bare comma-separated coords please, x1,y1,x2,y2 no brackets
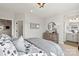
0,34,64,56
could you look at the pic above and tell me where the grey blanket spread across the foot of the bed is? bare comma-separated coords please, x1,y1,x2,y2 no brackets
25,38,64,56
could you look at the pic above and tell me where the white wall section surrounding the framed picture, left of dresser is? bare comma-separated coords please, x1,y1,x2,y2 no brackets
23,14,44,38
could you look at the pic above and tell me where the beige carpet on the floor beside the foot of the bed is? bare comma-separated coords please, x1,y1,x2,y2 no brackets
60,44,79,56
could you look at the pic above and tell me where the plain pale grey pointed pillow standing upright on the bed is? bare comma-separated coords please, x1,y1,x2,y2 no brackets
14,36,25,52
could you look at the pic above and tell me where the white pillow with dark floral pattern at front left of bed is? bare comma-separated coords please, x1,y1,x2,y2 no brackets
0,40,18,56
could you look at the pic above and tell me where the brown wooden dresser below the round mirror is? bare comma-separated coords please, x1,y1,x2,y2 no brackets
43,31,58,43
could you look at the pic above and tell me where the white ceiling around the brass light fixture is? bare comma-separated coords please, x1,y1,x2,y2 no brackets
0,3,79,18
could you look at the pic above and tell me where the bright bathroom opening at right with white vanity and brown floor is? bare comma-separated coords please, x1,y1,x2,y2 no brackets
64,19,79,47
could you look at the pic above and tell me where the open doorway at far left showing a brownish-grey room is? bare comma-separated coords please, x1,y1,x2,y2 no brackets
0,19,12,36
